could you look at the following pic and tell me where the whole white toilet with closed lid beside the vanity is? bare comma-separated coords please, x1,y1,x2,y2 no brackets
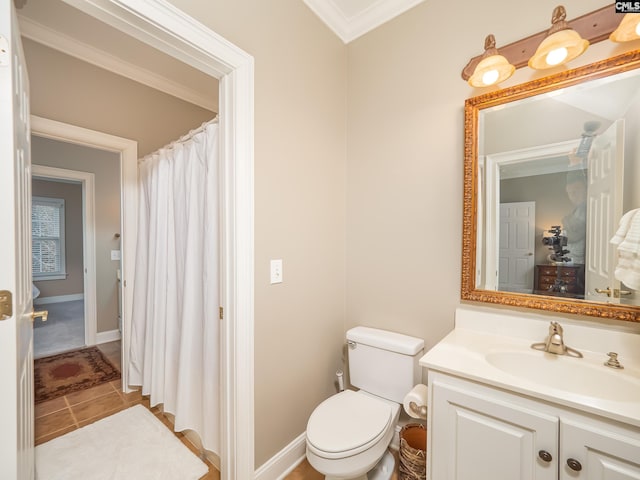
307,327,424,479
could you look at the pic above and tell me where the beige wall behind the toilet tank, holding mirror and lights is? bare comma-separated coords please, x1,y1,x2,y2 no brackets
346,0,630,348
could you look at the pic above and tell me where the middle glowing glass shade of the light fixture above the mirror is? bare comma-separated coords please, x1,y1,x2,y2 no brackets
529,5,589,70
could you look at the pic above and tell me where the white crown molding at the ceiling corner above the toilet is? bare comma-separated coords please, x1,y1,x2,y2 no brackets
304,0,424,43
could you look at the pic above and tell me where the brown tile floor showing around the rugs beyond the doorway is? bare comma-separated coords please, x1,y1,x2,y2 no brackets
35,342,220,480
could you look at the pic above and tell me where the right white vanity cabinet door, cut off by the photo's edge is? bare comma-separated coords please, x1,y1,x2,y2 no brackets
560,418,640,480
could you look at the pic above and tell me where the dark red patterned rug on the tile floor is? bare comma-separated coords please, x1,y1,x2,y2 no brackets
33,347,120,403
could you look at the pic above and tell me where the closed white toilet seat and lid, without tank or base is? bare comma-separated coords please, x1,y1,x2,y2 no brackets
307,390,393,458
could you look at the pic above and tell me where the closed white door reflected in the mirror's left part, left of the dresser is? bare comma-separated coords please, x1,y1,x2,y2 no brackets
498,202,536,293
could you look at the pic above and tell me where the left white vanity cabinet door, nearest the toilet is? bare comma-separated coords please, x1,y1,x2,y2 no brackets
427,375,559,480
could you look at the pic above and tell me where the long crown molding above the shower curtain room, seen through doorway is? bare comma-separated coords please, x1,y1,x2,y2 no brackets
18,14,218,112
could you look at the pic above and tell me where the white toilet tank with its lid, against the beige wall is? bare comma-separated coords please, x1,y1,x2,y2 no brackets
347,327,424,403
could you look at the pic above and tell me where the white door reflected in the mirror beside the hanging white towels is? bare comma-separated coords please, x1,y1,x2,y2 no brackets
585,120,624,303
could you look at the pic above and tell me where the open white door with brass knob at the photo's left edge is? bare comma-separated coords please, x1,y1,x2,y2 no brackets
0,0,34,480
